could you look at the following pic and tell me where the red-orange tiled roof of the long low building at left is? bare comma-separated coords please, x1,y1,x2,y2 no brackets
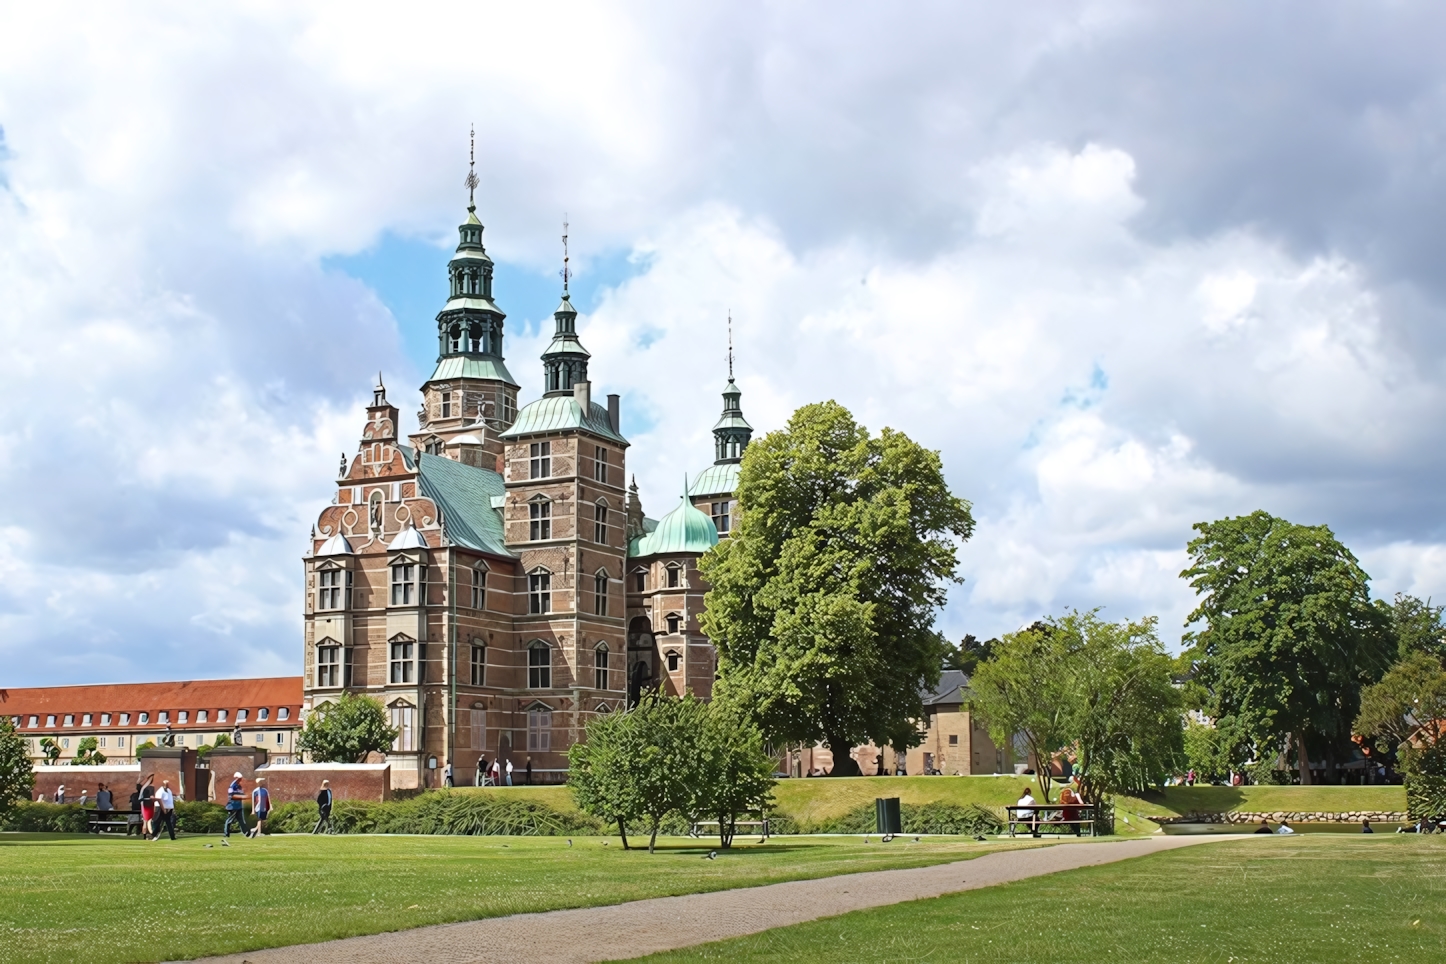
0,676,302,733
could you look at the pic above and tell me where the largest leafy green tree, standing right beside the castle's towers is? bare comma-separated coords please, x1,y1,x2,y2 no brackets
700,402,975,776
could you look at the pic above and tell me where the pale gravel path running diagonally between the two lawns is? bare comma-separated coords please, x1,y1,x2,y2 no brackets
195,834,1249,964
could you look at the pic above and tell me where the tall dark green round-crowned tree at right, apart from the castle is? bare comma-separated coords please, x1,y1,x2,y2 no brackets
1180,512,1395,783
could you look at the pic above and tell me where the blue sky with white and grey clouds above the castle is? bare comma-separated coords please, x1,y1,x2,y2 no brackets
0,0,1446,685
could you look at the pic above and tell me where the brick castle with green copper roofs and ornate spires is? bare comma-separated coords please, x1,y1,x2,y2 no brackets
304,193,752,788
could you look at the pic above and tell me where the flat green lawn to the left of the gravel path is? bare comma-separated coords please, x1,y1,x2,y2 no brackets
0,834,1041,961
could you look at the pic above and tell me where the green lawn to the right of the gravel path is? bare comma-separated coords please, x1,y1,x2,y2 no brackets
641,834,1446,964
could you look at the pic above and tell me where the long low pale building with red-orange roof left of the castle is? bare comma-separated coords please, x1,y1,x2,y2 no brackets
0,676,302,763
